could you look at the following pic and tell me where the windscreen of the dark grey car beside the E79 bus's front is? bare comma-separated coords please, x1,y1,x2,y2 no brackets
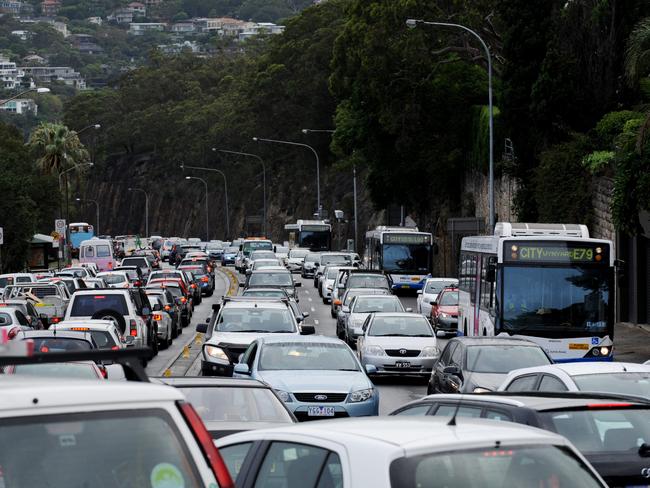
467,344,550,374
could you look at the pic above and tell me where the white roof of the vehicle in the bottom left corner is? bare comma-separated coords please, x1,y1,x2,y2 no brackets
0,375,184,416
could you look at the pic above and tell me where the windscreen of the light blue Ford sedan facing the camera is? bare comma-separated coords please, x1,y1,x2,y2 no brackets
259,342,359,371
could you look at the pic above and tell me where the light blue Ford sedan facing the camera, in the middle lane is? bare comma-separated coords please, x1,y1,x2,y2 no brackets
234,335,379,421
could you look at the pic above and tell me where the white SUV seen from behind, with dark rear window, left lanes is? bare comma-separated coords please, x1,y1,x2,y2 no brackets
65,288,158,354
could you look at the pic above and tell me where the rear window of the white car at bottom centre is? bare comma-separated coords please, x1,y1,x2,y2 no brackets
390,445,603,488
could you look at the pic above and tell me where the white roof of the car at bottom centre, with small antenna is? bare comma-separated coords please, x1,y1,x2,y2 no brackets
218,416,568,456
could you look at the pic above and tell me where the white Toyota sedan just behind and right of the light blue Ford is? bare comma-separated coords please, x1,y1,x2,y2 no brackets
355,313,440,376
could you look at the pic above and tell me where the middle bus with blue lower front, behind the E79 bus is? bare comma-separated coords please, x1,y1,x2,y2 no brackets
364,226,433,290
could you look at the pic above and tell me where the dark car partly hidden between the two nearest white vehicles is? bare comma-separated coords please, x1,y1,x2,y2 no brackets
159,376,297,439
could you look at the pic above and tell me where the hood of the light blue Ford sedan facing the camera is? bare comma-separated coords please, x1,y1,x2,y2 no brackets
257,370,372,393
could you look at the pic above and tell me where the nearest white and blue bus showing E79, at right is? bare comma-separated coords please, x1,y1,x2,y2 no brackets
458,222,615,362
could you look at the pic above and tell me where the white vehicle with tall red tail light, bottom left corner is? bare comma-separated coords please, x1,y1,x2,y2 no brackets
0,362,234,488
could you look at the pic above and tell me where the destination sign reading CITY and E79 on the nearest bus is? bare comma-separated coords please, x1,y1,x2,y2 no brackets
503,241,609,264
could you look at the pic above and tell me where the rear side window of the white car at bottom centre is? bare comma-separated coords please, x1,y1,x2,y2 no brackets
254,442,343,488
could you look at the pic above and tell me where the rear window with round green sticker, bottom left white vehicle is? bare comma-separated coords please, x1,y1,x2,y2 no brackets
0,407,204,488
